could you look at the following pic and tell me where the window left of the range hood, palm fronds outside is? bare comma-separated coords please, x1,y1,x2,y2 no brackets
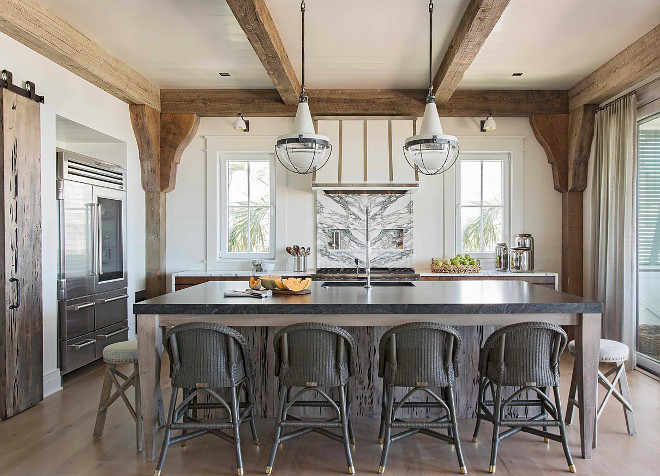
221,156,275,258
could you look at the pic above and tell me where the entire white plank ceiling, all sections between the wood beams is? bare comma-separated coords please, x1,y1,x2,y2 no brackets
40,0,660,89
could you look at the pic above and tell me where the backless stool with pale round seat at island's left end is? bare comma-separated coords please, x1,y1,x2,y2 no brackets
94,340,165,451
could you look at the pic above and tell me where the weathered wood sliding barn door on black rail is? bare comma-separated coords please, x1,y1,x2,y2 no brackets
0,89,42,418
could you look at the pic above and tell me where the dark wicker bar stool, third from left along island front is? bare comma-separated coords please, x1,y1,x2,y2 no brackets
378,322,467,474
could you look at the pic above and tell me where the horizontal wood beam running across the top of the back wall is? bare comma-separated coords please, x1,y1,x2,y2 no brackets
161,89,568,117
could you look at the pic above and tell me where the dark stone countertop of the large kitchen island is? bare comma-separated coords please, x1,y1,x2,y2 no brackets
133,280,603,314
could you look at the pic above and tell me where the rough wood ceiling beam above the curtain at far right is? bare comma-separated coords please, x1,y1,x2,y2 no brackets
568,25,660,111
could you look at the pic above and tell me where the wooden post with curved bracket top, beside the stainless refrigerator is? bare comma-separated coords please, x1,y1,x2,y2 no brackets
130,104,199,298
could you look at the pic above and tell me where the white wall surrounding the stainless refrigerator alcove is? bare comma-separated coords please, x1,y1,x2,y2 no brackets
0,33,145,395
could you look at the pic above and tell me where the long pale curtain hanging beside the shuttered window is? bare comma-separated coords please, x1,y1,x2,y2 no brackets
587,94,637,368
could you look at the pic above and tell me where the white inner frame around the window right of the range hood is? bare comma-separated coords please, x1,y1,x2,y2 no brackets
454,152,511,260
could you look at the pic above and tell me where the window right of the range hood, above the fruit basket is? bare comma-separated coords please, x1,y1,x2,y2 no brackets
456,154,510,258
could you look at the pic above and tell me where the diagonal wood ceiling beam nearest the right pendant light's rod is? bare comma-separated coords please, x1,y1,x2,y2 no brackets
433,0,509,103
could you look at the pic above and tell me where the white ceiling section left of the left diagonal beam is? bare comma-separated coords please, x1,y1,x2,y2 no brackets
39,0,273,89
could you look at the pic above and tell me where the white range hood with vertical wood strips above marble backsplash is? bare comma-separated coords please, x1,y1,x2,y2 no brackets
312,117,419,191
